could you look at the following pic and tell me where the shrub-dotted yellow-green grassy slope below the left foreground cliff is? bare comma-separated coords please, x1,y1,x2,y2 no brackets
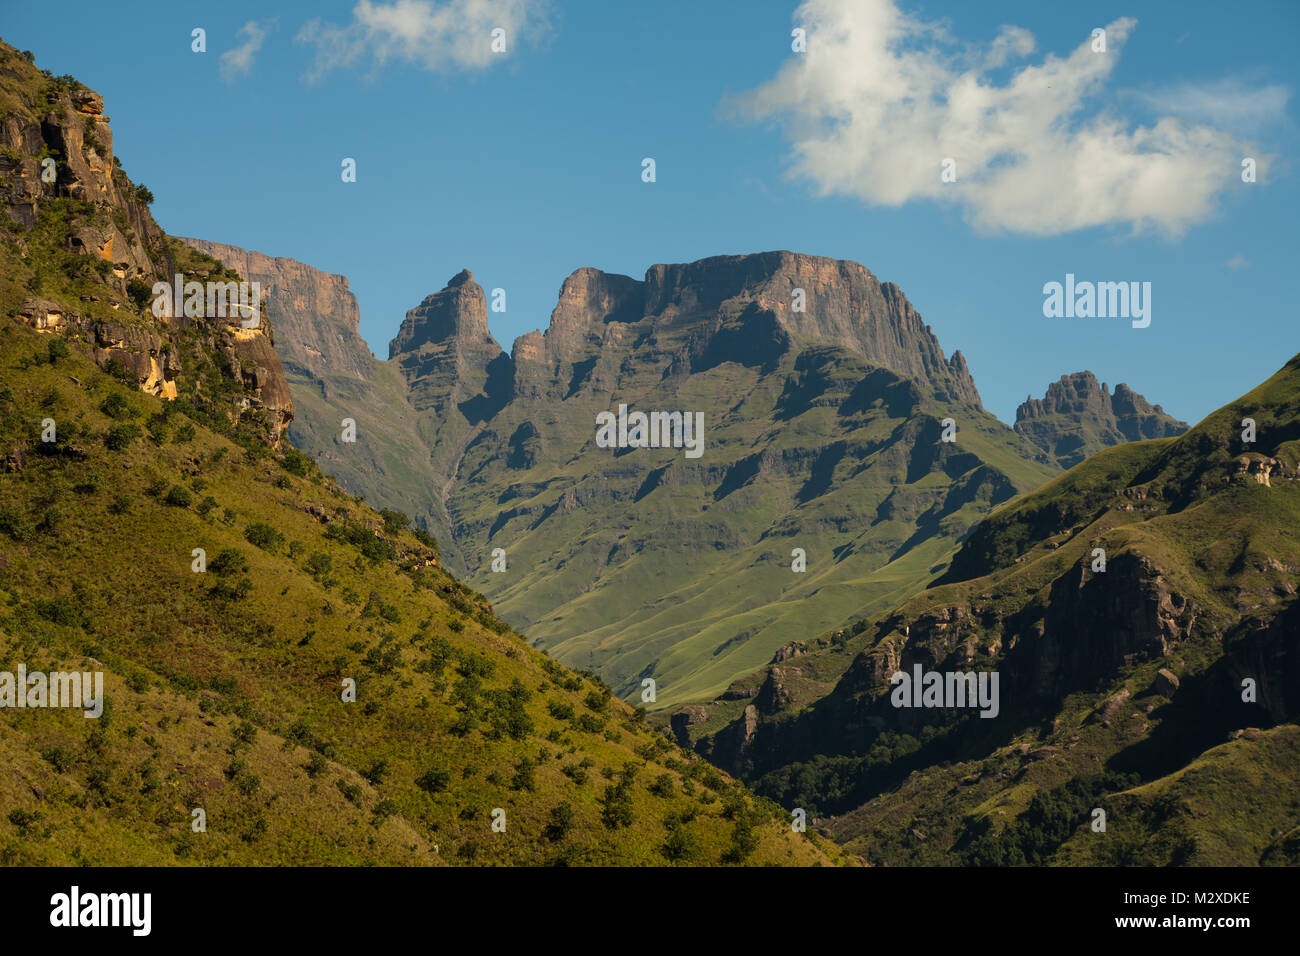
0,320,827,864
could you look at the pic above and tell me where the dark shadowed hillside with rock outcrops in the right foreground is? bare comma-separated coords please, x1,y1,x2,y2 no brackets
672,355,1300,865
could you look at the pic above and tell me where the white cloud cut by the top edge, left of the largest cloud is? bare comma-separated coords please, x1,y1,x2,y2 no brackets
298,0,546,81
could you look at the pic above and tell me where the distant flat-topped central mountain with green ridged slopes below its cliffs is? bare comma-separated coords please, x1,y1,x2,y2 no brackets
226,246,1054,706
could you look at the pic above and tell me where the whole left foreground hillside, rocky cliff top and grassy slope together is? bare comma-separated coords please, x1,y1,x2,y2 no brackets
0,47,841,865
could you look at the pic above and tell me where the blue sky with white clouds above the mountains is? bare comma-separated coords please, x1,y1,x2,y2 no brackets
0,0,1300,421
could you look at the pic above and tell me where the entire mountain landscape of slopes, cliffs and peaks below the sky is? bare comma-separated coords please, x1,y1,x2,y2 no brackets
0,37,1300,865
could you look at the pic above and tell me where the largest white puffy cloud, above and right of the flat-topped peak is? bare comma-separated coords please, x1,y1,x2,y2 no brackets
729,0,1277,235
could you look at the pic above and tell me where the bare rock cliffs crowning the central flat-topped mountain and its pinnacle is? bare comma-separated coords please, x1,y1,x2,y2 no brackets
389,251,980,406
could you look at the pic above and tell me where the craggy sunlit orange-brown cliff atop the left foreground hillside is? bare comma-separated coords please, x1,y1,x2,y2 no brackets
0,42,294,442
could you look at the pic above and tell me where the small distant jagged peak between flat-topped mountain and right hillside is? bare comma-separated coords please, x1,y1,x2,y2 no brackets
1015,372,1187,468
